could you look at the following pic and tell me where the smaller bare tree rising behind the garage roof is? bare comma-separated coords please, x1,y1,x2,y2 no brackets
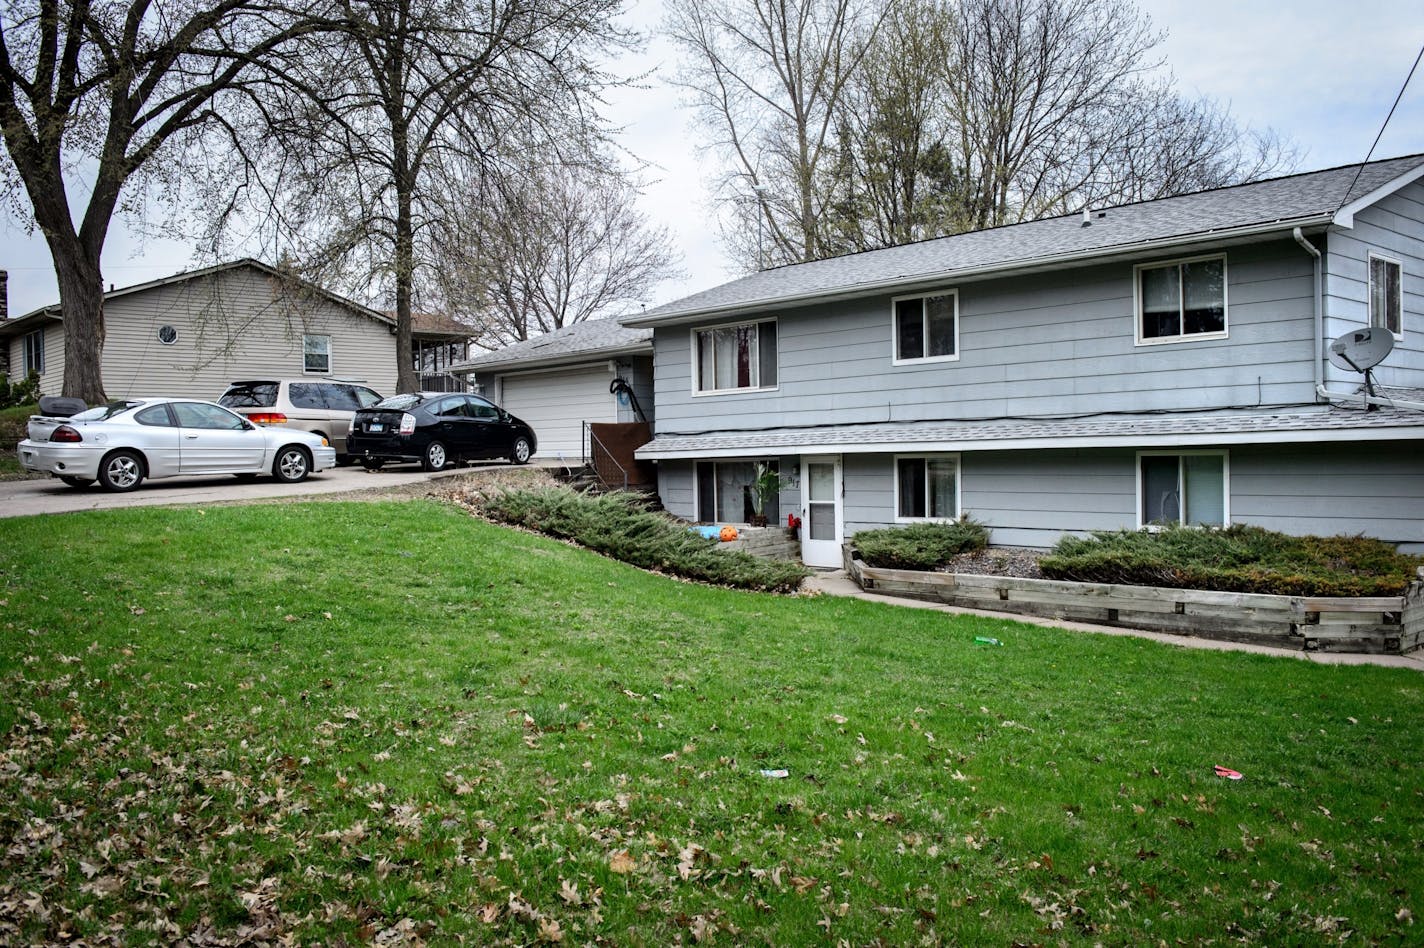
437,157,678,349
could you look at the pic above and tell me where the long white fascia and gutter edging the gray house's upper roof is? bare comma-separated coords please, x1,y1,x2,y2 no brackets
619,214,1331,326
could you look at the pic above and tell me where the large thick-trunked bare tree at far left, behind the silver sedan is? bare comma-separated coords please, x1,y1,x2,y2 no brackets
0,0,318,403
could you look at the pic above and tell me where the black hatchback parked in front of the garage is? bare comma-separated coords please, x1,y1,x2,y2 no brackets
346,391,538,471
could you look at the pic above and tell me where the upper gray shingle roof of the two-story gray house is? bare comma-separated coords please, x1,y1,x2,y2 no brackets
625,155,1424,325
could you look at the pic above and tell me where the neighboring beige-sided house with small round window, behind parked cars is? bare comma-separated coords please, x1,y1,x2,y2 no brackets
0,259,396,399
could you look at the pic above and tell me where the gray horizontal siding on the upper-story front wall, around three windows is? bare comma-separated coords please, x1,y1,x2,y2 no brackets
655,242,1313,433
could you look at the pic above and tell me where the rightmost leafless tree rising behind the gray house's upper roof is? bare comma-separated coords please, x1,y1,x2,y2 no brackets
947,0,1293,228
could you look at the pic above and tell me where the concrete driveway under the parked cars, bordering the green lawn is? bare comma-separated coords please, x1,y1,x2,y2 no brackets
0,465,449,517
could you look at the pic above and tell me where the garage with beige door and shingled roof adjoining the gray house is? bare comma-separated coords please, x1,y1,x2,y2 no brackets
451,319,652,463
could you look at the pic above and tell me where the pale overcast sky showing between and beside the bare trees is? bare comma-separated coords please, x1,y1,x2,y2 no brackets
0,0,1424,316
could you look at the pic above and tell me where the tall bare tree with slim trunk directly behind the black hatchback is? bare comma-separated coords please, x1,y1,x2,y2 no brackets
215,0,632,391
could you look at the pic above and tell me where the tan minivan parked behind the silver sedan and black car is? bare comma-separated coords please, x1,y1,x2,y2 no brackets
218,379,380,463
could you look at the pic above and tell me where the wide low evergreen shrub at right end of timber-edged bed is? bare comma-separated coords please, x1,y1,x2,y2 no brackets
1038,524,1424,596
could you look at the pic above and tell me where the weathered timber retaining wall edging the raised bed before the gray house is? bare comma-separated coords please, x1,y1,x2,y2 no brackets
844,547,1424,655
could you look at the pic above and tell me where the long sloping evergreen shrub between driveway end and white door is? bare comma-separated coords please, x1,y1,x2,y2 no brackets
484,487,810,592
